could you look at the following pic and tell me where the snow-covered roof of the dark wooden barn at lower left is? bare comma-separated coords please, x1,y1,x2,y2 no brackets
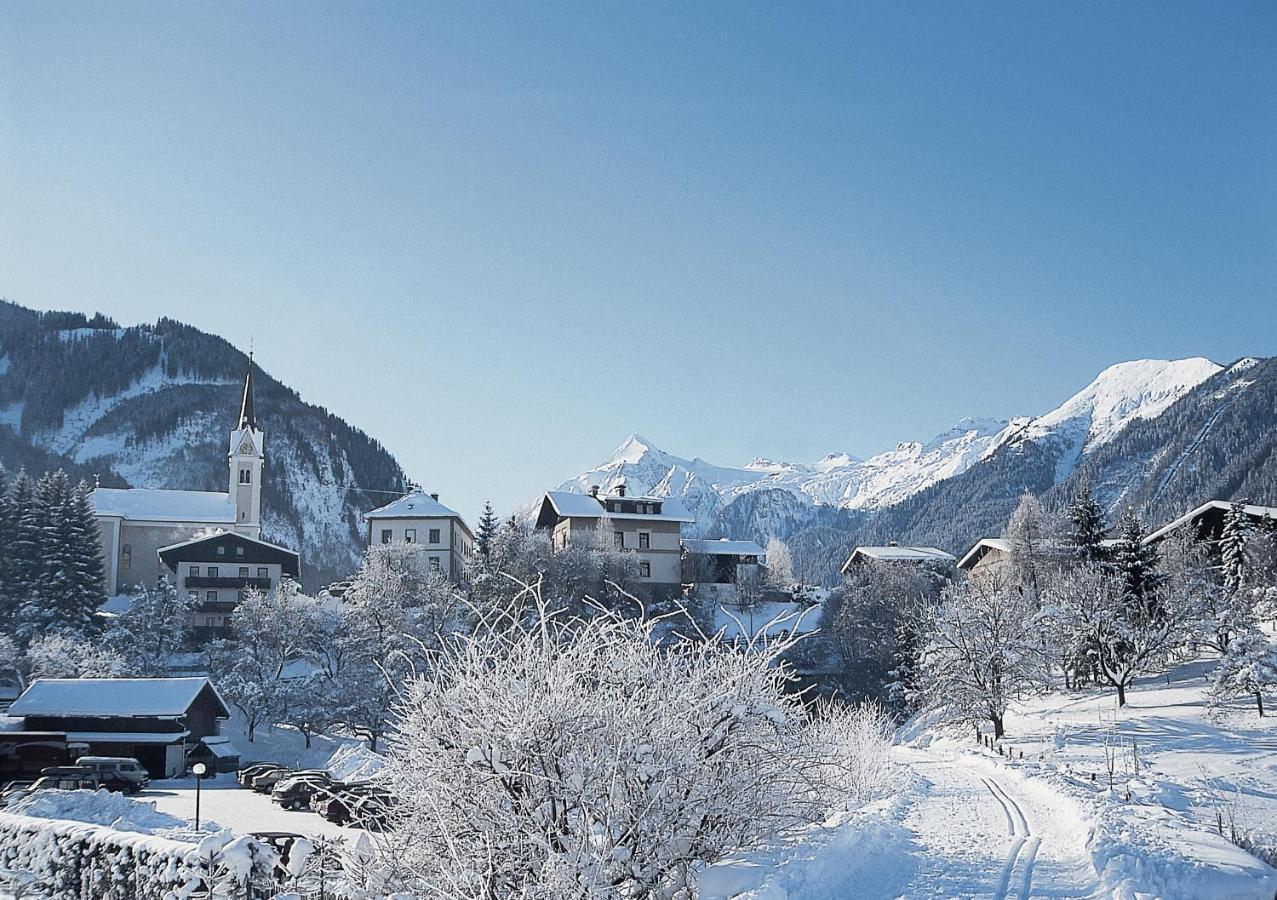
9,677,230,717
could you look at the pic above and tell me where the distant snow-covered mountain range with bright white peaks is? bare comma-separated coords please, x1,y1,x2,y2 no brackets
559,357,1221,532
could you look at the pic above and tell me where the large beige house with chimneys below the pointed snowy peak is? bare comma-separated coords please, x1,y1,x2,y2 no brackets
536,484,696,592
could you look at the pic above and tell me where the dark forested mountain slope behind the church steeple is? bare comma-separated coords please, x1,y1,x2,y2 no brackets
0,301,405,589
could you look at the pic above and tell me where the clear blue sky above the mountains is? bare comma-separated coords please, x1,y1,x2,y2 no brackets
0,3,1277,514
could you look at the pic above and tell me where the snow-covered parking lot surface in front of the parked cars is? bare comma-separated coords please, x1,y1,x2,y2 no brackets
144,775,361,843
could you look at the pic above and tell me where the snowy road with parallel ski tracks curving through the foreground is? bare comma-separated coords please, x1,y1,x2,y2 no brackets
896,748,1097,900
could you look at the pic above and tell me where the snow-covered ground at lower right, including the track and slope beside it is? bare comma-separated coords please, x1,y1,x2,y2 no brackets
702,660,1277,900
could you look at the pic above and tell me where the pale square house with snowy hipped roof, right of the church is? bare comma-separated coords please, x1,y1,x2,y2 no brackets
364,490,475,583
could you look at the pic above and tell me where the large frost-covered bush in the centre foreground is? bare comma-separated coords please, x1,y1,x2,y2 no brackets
383,587,885,900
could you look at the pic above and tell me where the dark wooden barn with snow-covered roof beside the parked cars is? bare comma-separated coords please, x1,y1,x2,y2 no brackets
9,678,231,779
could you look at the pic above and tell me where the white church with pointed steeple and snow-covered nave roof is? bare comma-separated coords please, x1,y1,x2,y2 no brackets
91,360,279,596
